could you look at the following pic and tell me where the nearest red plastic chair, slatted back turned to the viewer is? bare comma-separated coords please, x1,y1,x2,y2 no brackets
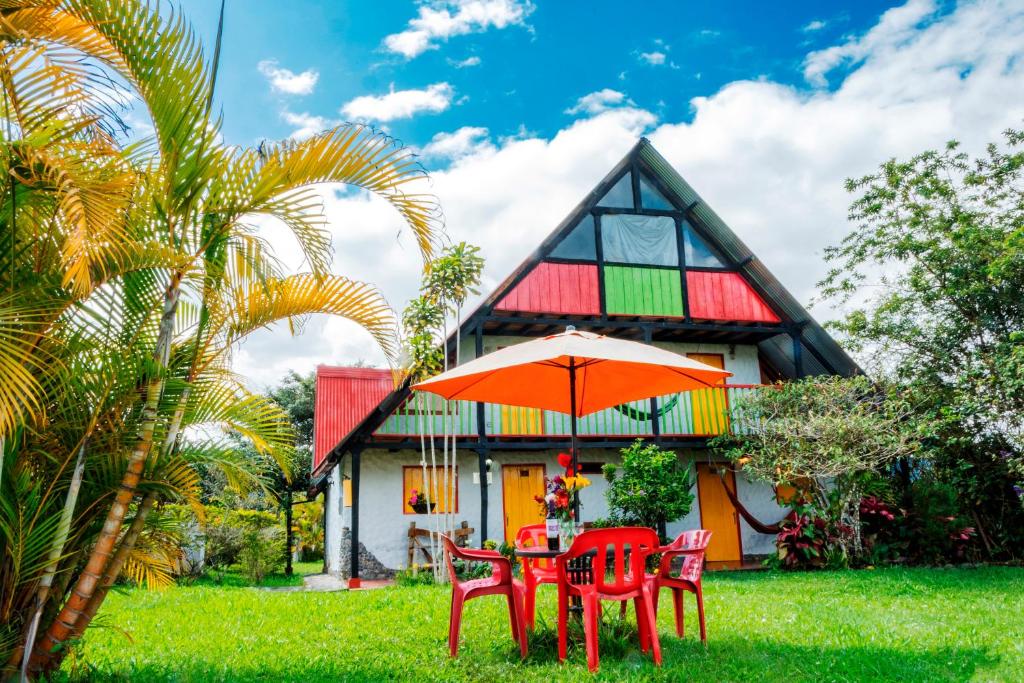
556,526,662,672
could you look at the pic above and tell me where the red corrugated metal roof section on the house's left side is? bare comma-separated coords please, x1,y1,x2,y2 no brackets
313,366,394,471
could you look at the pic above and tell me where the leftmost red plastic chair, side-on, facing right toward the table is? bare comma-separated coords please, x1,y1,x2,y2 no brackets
440,533,526,657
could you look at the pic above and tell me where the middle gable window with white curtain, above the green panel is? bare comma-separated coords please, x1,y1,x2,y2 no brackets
601,214,679,265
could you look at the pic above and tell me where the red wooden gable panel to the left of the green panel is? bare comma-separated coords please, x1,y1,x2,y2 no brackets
495,262,601,315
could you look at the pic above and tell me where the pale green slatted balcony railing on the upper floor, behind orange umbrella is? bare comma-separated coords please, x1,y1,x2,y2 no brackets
377,384,760,437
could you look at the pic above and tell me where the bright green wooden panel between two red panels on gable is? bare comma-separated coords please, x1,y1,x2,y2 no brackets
604,265,683,317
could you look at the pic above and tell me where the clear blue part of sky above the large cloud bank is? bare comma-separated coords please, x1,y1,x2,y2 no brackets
184,0,917,150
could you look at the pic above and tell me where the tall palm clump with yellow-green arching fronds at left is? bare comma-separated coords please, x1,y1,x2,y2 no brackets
0,0,439,673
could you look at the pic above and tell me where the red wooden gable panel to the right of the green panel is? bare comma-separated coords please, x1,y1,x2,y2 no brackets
686,270,779,323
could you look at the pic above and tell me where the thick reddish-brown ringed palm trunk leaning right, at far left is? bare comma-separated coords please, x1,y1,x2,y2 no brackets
30,272,181,672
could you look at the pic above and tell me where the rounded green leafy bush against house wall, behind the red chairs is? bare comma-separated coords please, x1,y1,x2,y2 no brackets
602,439,693,539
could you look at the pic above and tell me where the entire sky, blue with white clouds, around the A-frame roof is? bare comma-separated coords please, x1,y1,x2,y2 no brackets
172,0,1024,388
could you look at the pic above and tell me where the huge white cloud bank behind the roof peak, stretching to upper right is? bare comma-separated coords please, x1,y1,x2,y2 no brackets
236,1,1024,386
